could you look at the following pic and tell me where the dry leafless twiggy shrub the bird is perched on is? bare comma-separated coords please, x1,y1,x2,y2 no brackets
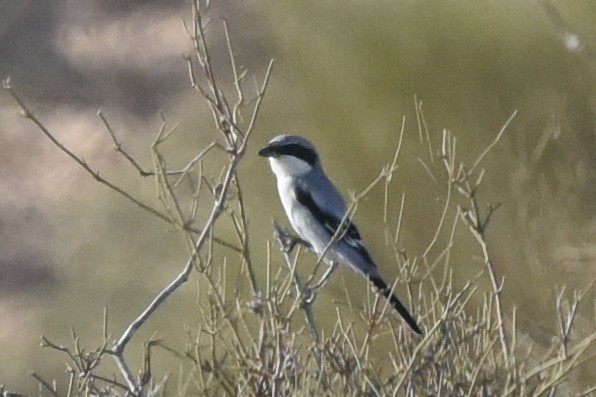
2,1,596,396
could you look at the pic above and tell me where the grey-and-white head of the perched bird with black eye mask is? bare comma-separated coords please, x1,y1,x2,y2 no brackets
259,134,320,178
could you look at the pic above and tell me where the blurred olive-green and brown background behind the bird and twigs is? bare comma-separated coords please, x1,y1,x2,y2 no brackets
0,0,596,392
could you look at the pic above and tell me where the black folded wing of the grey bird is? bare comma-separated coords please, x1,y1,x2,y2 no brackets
296,186,376,267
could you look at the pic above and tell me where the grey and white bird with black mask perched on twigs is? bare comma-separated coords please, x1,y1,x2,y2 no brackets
258,134,422,334
